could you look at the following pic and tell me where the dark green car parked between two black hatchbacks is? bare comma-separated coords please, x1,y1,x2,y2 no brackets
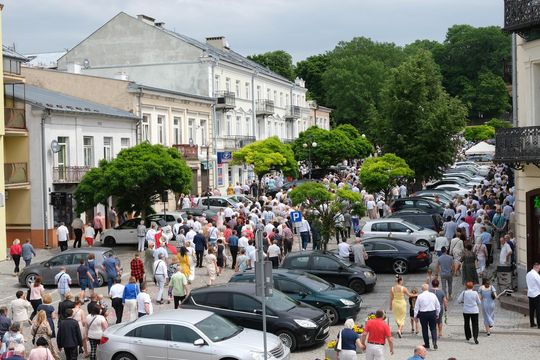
229,269,362,325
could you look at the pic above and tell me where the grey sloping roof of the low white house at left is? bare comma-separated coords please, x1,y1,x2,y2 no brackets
6,85,139,119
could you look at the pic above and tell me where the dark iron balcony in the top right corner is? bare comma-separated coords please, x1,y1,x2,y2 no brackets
504,0,540,38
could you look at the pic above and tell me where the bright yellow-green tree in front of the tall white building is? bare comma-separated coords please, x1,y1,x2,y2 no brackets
232,136,298,180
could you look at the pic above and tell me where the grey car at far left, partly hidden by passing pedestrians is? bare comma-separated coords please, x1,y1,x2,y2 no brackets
19,247,115,287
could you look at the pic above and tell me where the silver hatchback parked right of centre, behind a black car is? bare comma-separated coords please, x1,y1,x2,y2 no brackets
360,218,437,248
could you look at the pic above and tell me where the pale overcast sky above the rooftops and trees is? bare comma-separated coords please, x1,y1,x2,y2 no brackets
0,0,504,60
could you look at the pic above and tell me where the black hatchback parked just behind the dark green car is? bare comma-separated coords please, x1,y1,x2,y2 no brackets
281,250,377,294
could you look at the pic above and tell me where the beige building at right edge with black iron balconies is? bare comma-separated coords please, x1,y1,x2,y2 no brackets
494,0,540,288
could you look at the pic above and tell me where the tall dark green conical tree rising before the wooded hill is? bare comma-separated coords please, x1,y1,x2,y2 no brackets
372,51,467,183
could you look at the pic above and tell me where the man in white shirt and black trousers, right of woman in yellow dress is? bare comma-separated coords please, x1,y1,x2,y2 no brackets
414,284,441,349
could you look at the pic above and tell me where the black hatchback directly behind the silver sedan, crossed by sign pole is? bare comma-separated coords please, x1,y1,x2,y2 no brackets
182,283,330,351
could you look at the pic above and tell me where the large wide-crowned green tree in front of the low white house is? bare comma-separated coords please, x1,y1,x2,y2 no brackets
75,142,191,216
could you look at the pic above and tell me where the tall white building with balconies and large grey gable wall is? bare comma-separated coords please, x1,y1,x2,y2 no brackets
54,13,329,189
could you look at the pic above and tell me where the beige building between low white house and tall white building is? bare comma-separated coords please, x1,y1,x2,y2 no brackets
22,67,215,197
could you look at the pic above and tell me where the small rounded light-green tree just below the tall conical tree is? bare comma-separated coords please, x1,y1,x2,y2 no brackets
360,153,414,198
